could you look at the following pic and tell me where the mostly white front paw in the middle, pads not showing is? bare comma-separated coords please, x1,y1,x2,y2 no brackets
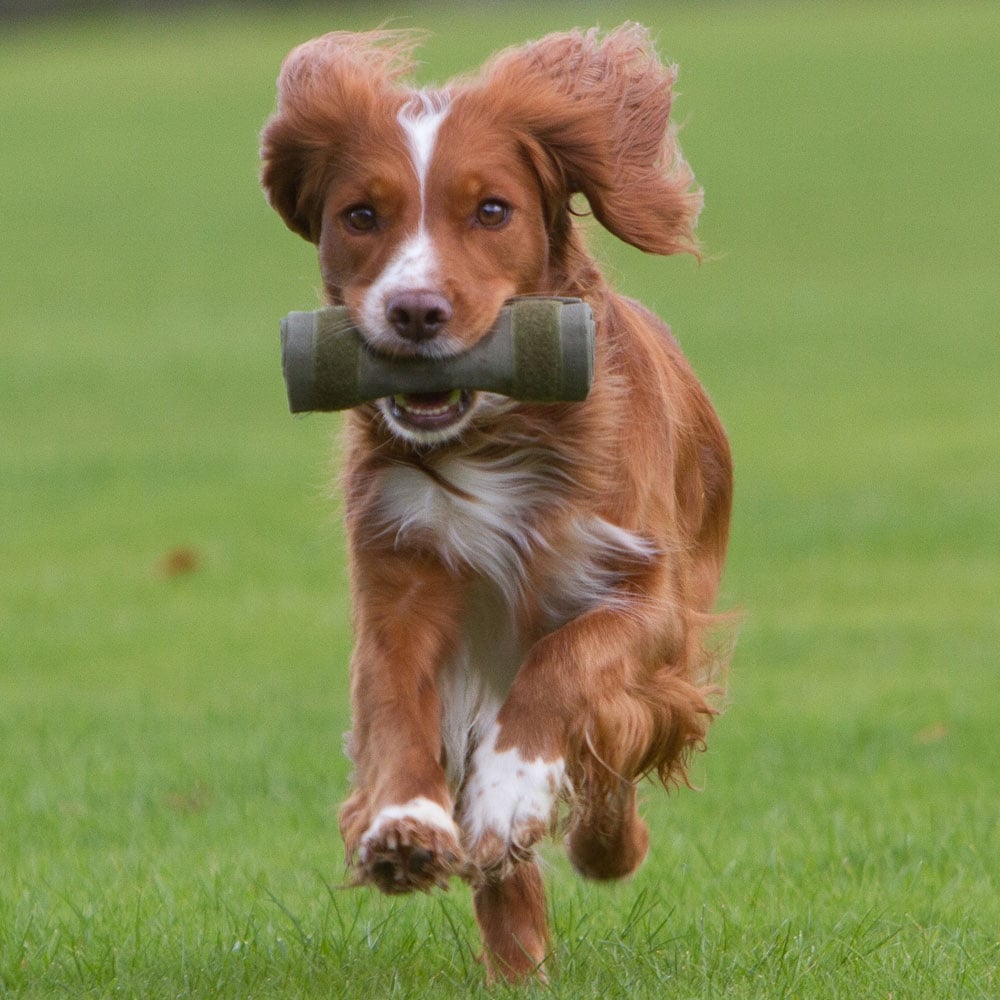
460,729,569,877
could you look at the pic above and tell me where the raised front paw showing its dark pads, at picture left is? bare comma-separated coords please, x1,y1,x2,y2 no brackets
354,798,461,895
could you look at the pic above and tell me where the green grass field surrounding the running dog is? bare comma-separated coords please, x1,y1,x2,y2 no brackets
0,0,1000,1000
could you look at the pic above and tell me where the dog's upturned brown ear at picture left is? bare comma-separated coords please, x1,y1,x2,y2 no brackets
260,31,422,243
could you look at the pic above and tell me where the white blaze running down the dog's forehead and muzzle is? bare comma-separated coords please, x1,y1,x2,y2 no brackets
361,91,450,341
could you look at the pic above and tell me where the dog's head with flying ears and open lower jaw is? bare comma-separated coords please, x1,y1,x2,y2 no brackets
261,25,701,444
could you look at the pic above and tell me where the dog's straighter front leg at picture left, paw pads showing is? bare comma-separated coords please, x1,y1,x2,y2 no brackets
340,551,460,893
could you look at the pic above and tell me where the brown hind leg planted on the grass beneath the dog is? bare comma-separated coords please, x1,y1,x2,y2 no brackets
474,861,549,981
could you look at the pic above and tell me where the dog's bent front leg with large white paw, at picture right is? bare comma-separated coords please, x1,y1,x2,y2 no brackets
461,592,697,872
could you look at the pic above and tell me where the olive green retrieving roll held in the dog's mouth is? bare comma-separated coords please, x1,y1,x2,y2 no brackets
281,296,594,413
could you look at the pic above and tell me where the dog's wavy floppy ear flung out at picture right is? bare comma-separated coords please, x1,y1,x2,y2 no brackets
484,24,702,254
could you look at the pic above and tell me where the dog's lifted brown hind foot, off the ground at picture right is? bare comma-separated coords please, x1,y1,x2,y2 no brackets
566,780,649,881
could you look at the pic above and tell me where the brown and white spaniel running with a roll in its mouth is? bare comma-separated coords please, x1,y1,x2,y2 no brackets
262,25,732,978
